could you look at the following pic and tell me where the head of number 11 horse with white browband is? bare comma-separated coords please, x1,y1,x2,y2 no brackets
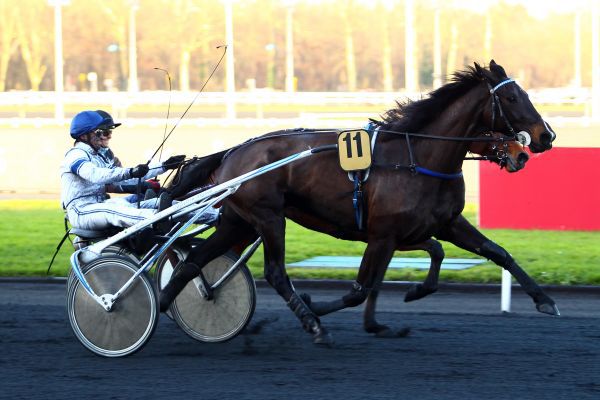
475,60,556,153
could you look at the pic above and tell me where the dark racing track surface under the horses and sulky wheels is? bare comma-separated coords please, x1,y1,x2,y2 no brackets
0,282,600,400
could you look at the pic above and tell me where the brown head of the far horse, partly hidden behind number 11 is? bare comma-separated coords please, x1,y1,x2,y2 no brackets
469,132,529,172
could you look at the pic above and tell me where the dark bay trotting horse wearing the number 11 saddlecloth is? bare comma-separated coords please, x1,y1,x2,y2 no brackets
160,61,558,343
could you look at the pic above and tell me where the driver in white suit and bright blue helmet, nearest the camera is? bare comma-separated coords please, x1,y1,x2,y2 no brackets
60,111,185,230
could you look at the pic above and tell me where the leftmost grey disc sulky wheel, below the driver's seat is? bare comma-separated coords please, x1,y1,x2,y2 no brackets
67,255,159,357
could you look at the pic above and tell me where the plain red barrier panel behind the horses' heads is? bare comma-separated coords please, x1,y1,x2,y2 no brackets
479,148,600,230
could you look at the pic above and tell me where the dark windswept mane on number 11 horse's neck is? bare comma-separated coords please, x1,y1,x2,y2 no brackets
372,67,485,132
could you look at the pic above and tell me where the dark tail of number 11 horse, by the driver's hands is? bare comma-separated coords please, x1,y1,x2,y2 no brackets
166,149,230,198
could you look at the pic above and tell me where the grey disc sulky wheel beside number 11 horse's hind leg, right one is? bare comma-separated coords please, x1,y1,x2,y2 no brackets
156,245,256,342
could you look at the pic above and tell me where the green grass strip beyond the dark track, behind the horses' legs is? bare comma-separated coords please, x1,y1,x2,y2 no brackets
0,200,600,285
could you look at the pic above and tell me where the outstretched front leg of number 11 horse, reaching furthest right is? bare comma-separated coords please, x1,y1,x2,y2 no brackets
436,215,560,315
